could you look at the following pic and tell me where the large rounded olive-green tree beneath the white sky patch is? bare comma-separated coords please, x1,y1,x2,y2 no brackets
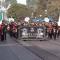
7,4,31,18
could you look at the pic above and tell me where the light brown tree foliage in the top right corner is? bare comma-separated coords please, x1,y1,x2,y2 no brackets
47,0,60,20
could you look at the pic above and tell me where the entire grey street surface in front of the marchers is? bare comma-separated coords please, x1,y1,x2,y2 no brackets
0,34,60,60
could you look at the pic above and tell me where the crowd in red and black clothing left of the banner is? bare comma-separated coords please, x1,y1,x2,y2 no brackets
0,22,18,41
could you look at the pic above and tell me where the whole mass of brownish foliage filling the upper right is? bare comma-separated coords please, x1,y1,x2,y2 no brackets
36,0,60,17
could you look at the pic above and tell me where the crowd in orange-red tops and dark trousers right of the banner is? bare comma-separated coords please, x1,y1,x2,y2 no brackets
46,23,60,40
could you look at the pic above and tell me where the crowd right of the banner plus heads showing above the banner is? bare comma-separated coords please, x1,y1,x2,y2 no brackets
18,22,60,40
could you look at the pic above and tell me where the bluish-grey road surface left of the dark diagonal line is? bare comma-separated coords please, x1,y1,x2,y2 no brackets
0,35,42,60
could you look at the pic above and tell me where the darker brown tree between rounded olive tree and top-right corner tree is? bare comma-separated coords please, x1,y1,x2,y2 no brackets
36,0,47,16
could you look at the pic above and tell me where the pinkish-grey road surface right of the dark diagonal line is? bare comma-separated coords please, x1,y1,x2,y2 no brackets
23,38,60,60
